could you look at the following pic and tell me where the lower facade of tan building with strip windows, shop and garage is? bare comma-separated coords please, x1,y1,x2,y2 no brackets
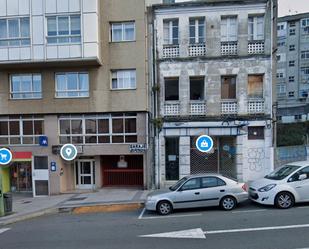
0,113,150,196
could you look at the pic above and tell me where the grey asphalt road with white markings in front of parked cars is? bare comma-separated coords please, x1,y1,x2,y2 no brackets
0,201,309,249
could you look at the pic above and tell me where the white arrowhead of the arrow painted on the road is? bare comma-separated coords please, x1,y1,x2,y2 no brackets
139,228,206,239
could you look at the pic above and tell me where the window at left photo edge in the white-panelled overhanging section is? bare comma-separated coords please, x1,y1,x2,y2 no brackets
0,17,30,47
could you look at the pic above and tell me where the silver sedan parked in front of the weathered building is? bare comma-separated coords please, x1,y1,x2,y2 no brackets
145,174,248,215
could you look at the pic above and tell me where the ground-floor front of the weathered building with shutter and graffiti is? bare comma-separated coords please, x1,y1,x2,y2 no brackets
156,120,274,186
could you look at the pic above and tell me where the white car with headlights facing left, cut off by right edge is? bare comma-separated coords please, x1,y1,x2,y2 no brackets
249,161,309,208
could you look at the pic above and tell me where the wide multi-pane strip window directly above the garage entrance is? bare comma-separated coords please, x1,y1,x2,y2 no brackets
59,113,137,144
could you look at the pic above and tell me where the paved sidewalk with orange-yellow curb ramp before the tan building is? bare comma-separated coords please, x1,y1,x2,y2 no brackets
0,188,149,226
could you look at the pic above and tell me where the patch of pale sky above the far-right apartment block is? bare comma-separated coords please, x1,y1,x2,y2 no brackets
278,0,309,17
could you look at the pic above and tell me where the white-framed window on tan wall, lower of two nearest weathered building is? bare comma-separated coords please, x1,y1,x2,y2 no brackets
112,70,136,90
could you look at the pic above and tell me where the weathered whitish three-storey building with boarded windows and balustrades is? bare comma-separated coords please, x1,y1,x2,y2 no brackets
148,0,277,186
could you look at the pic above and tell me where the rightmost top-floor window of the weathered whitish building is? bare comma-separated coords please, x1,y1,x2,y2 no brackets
248,16,264,41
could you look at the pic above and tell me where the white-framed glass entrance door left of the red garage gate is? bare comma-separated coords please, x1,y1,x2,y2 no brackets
76,160,95,189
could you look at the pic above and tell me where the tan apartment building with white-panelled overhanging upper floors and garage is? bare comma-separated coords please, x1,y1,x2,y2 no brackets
0,0,150,195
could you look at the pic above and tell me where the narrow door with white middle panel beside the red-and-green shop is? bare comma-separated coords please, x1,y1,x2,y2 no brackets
32,156,49,197
